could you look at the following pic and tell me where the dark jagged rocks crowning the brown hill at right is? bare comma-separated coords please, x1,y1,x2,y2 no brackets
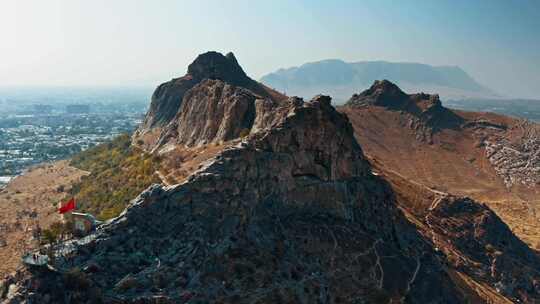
345,80,463,143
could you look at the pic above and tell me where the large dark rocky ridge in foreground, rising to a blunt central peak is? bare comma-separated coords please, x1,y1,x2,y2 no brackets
1,96,462,303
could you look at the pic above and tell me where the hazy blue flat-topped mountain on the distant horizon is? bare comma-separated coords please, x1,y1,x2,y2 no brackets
261,59,497,103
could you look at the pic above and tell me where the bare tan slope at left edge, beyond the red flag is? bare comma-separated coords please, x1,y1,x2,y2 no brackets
0,161,87,277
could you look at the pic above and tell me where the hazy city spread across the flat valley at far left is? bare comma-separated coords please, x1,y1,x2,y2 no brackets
0,90,147,187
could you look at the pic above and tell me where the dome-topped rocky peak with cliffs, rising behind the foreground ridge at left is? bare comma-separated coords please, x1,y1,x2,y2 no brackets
134,52,286,150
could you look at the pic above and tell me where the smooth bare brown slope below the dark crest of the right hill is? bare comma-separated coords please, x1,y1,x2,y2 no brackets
339,106,540,249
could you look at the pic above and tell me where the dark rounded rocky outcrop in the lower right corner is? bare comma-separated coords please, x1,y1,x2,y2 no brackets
426,196,540,303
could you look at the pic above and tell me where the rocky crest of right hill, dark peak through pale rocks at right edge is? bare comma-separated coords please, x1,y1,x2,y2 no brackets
343,80,540,192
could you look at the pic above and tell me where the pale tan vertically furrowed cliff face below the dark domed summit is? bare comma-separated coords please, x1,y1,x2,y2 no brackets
157,79,302,147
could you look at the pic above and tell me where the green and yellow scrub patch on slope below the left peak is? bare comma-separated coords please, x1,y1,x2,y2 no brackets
71,134,160,220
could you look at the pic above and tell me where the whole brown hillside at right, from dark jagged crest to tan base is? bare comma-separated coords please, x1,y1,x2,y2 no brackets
339,81,540,248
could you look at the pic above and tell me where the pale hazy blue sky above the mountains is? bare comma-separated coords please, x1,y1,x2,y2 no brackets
0,0,540,99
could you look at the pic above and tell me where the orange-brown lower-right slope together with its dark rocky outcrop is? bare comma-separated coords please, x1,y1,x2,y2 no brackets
374,162,540,303
